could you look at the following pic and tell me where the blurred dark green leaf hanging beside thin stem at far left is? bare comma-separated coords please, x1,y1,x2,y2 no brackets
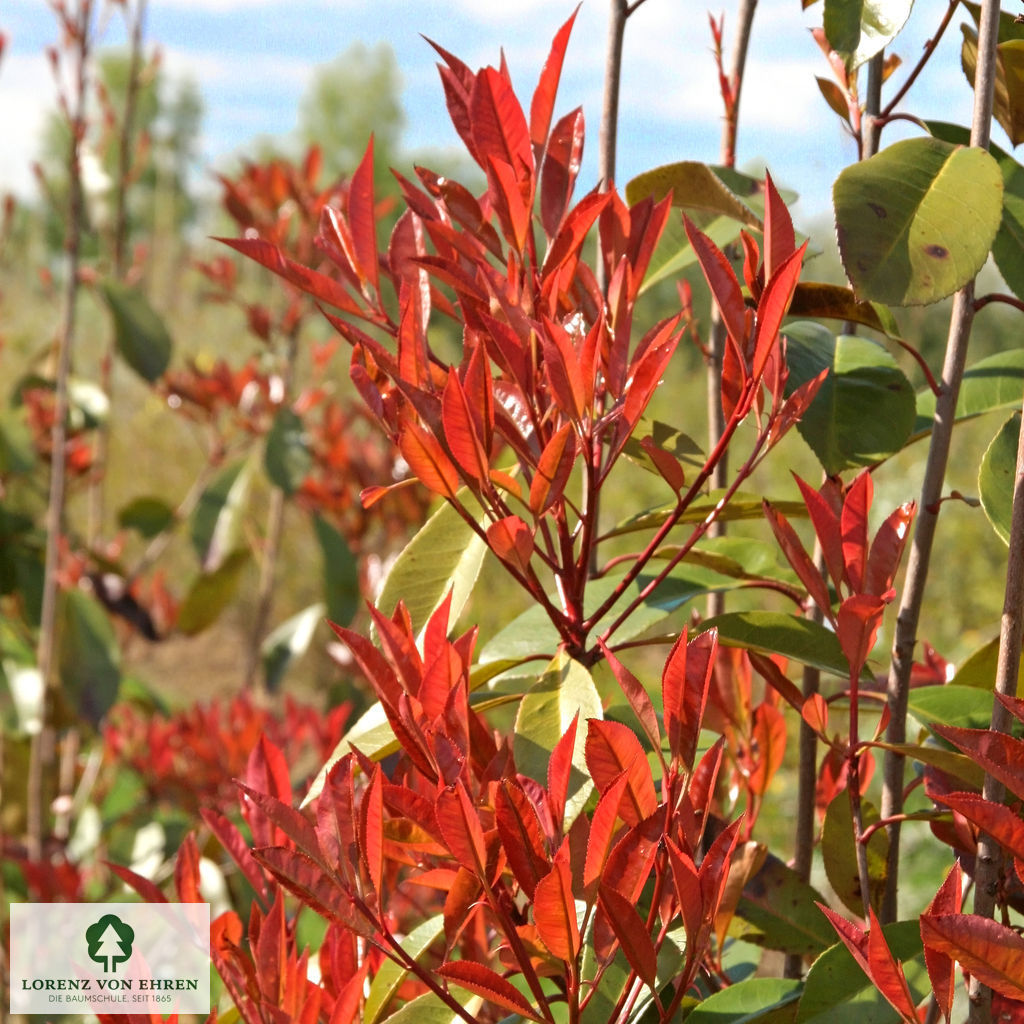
57,589,121,726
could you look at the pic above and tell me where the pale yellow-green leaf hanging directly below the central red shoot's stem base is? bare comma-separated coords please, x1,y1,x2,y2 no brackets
512,651,604,827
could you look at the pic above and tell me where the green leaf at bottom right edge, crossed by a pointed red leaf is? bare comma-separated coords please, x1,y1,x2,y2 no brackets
797,921,931,1024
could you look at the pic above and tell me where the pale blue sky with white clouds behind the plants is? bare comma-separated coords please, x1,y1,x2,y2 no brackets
0,0,974,220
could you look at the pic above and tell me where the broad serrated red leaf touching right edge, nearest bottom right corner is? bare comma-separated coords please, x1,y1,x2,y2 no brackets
921,913,1024,999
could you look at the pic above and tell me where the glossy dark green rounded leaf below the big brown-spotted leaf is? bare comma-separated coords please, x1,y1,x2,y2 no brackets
785,321,916,476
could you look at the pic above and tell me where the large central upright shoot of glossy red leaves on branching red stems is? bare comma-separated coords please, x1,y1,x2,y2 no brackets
230,18,820,664
